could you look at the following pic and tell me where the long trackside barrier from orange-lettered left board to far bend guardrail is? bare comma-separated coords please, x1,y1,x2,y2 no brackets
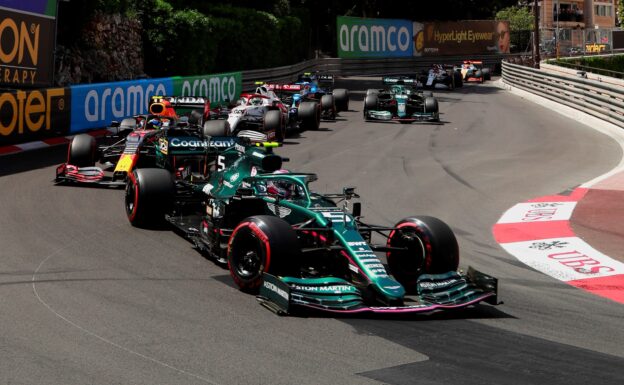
0,55,513,147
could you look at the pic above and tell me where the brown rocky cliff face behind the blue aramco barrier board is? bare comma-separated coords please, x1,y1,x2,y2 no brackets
56,13,144,86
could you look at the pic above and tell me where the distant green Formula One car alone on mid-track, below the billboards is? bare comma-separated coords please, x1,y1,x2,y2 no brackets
364,76,440,123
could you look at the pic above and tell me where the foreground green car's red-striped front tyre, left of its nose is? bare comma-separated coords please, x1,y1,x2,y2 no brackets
227,215,300,293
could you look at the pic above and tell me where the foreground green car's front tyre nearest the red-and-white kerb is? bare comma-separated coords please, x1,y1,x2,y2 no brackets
386,216,459,291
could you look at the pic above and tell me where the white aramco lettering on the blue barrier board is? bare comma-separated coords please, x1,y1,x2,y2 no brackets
84,83,167,122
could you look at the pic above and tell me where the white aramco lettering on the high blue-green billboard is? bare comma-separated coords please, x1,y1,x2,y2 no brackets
338,24,412,52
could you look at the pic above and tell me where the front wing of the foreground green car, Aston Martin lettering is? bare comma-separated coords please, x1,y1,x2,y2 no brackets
258,268,498,315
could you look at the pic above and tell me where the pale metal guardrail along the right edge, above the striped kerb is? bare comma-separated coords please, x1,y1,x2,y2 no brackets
502,61,624,128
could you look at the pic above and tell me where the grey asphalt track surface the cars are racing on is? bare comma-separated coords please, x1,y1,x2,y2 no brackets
0,79,624,384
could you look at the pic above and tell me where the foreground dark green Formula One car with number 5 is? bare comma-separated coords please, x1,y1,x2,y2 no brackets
125,138,497,314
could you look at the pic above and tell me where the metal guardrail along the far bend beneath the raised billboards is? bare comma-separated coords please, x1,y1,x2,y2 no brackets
242,55,514,90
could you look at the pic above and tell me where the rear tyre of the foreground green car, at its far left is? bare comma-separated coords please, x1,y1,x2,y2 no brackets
125,168,175,227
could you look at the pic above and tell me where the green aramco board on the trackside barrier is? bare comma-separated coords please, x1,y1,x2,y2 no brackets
176,72,243,104
